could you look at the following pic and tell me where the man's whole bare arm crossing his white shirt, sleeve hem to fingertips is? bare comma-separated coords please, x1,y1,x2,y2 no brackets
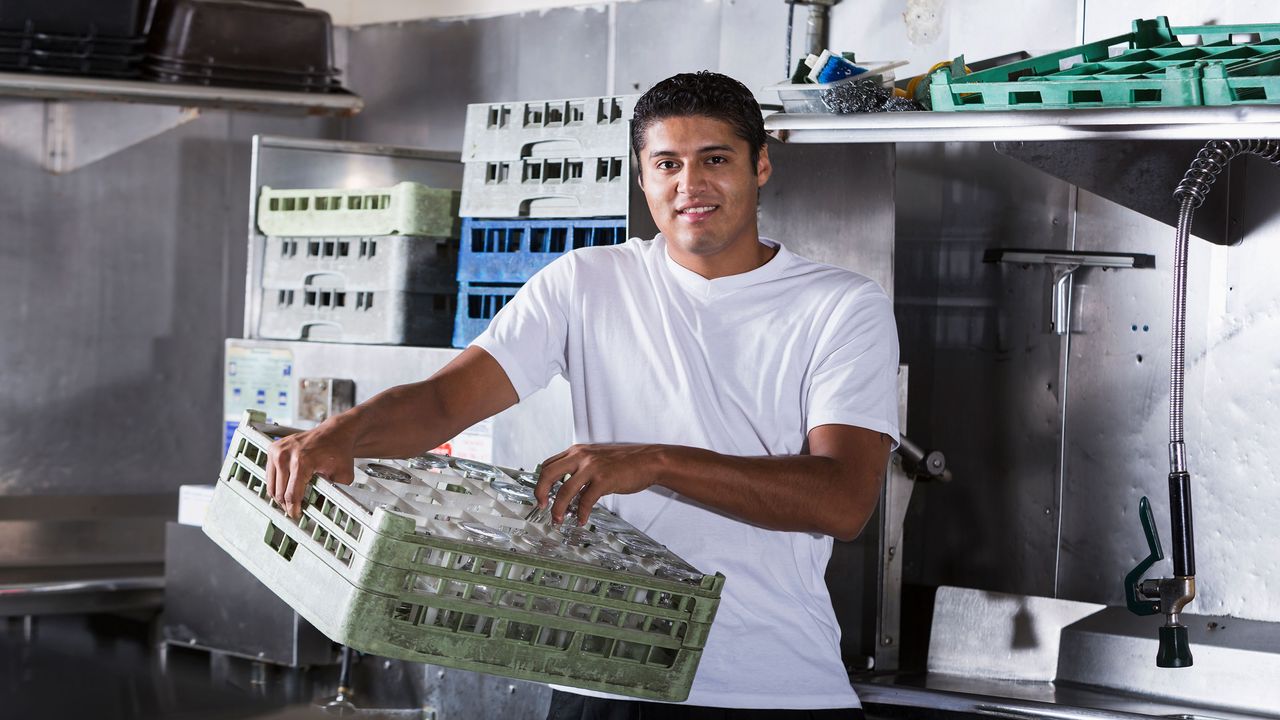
534,424,892,541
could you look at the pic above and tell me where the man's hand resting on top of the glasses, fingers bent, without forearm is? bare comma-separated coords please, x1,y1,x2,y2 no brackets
534,445,662,525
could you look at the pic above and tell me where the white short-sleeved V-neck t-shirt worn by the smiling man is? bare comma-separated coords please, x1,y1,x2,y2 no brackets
475,234,897,710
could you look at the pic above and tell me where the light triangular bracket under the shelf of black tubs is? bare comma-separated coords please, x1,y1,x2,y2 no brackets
0,100,200,174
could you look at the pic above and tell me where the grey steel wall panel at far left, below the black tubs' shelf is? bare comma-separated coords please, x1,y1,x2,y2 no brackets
0,113,335,495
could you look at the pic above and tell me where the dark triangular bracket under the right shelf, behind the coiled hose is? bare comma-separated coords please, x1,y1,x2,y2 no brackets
996,140,1244,245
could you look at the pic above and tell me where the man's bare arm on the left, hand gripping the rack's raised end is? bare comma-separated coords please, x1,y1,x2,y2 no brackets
266,346,520,518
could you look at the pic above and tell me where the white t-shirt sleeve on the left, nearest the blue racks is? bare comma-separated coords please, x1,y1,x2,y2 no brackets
471,255,573,400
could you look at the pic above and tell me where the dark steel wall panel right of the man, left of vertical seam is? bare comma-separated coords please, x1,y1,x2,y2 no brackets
895,145,1070,596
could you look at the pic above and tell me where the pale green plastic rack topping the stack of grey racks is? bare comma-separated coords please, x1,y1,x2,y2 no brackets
257,182,462,238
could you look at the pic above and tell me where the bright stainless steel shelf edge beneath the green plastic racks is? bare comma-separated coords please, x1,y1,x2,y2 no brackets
764,105,1280,143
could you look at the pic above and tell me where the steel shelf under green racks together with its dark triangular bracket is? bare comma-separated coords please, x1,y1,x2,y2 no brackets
764,105,1280,245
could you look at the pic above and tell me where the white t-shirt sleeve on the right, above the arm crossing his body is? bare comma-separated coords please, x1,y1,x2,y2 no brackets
805,288,899,447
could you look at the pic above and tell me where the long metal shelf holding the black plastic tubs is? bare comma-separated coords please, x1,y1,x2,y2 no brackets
0,73,365,115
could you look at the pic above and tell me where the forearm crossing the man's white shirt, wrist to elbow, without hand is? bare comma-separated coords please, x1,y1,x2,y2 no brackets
655,446,884,539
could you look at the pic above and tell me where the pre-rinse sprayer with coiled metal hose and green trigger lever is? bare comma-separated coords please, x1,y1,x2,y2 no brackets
1125,140,1280,667
